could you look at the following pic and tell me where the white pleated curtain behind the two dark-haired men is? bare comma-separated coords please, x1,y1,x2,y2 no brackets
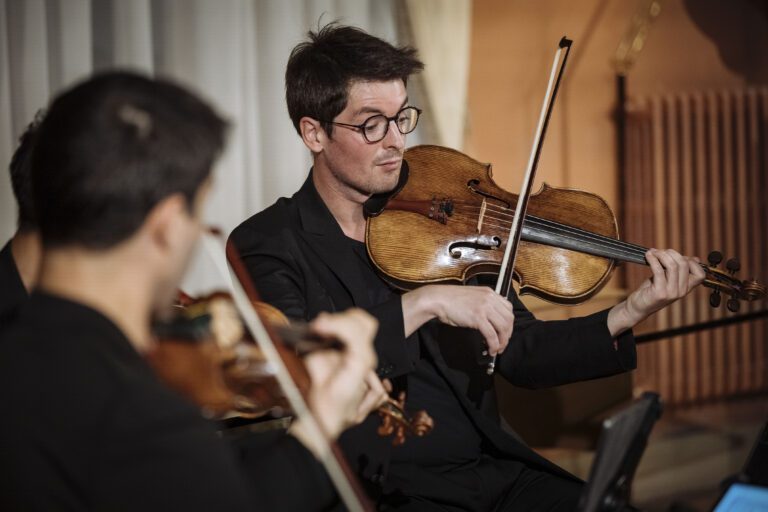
0,0,398,292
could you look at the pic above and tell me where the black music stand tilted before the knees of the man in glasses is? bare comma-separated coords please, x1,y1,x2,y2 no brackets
579,392,661,512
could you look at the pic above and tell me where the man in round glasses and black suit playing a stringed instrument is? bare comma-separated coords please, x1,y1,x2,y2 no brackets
231,24,704,511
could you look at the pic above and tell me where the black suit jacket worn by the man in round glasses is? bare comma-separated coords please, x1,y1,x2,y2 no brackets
230,173,636,492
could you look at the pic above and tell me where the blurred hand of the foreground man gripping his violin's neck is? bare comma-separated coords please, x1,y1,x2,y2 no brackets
291,309,386,457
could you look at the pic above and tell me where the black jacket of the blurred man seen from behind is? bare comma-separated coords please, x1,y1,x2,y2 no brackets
0,294,335,512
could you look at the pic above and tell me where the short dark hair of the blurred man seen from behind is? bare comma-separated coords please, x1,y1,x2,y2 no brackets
32,72,226,249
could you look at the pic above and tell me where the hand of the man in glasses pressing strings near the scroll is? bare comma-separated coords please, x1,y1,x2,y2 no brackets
608,249,705,336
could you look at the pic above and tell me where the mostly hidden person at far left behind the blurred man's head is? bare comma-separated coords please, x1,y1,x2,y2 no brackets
0,114,42,324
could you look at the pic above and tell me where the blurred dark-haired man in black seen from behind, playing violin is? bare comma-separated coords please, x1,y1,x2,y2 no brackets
0,73,383,511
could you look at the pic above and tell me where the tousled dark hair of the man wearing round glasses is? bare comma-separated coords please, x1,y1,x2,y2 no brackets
285,23,424,136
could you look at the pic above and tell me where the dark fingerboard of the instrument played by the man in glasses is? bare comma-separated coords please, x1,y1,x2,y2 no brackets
522,215,648,265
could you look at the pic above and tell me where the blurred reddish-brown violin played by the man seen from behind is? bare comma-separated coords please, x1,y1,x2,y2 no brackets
149,292,434,446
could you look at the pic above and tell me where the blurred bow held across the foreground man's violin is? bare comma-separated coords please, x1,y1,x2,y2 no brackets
203,233,373,512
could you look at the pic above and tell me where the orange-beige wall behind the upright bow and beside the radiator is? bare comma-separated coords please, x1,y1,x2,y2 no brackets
465,0,768,444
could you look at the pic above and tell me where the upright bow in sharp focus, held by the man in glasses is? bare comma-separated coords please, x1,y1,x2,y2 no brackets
483,36,573,375
